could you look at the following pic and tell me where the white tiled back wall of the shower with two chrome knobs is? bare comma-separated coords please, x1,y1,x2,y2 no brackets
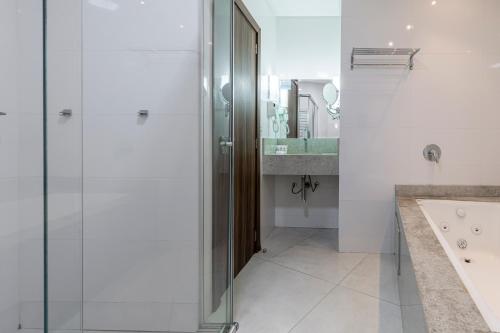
15,0,201,333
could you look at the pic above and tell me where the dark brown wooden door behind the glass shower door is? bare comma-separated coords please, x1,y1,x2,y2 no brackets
233,1,260,276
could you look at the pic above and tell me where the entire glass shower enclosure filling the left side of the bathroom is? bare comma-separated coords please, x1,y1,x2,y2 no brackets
0,0,232,333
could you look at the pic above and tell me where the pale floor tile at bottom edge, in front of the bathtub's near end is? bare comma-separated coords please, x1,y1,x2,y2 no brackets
291,286,402,333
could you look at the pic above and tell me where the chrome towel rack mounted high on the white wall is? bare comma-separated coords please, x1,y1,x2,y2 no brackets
351,47,420,70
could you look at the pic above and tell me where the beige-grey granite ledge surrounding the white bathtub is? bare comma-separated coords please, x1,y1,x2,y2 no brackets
396,185,500,333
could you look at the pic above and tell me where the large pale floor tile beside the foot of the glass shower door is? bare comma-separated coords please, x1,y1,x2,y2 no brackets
235,258,334,333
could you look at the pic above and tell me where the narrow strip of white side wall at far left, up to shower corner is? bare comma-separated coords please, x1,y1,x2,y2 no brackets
0,0,19,326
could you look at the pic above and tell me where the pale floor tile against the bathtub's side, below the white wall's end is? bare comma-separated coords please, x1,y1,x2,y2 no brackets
342,254,399,304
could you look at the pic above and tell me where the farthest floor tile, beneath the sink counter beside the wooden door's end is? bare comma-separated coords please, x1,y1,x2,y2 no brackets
257,228,318,258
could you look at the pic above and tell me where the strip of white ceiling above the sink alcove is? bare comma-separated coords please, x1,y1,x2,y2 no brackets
267,0,341,16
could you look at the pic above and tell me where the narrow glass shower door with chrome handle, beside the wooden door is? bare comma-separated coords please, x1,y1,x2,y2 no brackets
203,0,235,332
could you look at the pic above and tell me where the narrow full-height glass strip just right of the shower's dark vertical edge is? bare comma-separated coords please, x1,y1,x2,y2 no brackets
45,0,83,333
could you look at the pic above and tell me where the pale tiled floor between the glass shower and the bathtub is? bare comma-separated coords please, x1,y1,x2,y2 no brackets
235,228,402,333
